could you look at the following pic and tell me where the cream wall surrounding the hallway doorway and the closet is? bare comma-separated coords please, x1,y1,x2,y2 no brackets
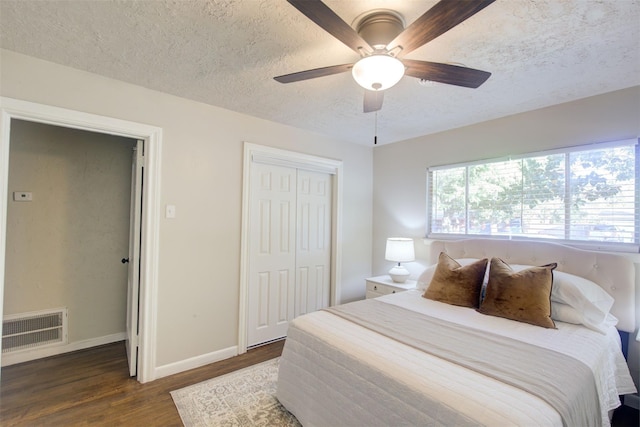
0,50,372,372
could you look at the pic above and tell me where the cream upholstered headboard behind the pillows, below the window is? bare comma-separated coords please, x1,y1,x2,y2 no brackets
429,239,636,332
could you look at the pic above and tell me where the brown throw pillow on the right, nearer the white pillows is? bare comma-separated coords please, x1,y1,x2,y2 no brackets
478,258,558,328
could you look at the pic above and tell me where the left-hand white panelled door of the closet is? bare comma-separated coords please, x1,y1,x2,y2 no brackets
247,163,296,346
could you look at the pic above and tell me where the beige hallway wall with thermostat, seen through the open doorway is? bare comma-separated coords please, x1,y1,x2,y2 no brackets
3,120,135,344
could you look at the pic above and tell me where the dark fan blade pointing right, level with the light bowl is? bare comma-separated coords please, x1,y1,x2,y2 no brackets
402,59,491,89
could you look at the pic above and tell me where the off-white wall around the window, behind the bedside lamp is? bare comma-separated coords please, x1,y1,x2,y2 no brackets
373,86,640,394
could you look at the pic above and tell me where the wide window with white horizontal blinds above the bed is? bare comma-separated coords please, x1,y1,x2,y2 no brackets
427,140,640,250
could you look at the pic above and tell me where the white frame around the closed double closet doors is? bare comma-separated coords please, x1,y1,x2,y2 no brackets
238,142,343,354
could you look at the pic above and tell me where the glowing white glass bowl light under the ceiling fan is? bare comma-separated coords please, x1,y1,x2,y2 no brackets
351,54,404,91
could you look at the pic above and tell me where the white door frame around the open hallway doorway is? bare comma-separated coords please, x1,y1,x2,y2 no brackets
0,97,162,383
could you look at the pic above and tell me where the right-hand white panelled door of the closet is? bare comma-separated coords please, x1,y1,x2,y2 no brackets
295,170,331,317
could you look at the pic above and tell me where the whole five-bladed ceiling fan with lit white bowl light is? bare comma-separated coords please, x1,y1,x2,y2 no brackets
274,0,495,113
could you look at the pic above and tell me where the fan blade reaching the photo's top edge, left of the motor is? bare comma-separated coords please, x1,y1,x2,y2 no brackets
287,0,373,53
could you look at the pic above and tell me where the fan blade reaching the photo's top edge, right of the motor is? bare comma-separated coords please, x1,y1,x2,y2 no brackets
387,0,495,57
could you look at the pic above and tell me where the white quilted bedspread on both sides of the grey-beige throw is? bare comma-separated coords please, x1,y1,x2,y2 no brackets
277,291,635,426
